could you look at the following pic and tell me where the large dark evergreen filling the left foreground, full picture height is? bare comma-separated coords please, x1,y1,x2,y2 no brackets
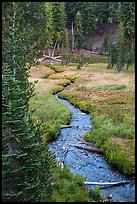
2,2,51,202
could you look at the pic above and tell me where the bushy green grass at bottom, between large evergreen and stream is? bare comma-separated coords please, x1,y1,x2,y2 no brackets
43,166,102,202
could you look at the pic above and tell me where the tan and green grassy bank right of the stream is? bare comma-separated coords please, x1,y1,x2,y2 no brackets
59,63,135,176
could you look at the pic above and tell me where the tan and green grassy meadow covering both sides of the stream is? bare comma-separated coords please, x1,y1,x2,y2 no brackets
30,62,135,176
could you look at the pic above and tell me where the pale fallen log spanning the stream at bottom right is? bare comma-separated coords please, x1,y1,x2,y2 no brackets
84,181,130,186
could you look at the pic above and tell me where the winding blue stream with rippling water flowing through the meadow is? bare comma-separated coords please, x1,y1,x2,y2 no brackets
49,87,135,202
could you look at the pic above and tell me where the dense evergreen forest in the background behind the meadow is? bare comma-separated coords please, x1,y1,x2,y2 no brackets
2,2,135,53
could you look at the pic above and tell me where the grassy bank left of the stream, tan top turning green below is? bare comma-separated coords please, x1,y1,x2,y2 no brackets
30,75,71,141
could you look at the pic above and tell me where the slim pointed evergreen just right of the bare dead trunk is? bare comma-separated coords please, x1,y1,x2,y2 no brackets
75,11,83,49
